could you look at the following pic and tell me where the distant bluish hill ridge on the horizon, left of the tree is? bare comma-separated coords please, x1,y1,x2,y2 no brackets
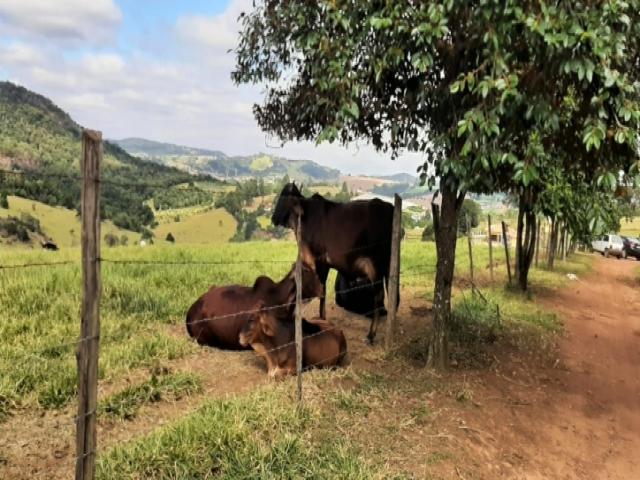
113,138,340,182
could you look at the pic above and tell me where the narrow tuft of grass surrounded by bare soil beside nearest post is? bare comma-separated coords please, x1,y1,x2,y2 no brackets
99,372,202,420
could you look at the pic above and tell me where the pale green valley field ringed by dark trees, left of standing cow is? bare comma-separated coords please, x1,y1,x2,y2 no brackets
153,209,237,244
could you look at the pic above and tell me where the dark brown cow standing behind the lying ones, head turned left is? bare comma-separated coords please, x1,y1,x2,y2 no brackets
271,183,393,343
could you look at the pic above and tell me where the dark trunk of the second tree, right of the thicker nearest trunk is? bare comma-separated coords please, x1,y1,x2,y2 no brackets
516,189,536,292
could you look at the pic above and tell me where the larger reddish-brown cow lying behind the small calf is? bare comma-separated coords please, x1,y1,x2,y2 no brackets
187,267,324,350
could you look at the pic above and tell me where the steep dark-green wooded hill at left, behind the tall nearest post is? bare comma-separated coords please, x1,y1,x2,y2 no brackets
0,82,222,231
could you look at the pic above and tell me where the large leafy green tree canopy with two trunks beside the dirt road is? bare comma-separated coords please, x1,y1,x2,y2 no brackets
232,0,640,365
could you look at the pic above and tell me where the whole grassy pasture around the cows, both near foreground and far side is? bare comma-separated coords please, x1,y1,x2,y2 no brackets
0,242,590,479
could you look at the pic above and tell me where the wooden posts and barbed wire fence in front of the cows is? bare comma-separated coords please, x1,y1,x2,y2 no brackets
0,140,404,480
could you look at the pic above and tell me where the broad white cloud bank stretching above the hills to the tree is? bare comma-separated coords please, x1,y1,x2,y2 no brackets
0,0,422,173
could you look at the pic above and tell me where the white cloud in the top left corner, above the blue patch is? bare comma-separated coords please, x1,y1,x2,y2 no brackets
0,0,122,44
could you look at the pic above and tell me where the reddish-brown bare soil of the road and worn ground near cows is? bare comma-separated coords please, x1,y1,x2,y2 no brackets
0,253,640,480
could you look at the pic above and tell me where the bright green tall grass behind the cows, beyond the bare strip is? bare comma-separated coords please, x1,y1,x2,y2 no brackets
0,240,588,415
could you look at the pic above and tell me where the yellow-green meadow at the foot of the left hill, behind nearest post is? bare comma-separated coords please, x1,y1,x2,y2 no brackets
0,196,140,248
